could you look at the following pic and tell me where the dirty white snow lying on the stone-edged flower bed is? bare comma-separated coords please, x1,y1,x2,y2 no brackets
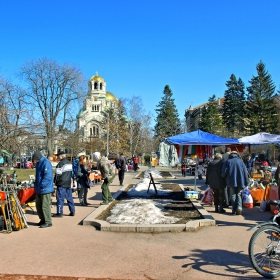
107,174,179,224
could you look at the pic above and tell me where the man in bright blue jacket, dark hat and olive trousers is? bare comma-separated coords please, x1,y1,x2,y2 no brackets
32,151,54,228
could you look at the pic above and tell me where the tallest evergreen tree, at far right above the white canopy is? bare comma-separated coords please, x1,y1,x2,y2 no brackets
246,61,277,134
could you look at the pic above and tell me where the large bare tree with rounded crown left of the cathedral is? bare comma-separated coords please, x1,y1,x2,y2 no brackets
20,58,86,155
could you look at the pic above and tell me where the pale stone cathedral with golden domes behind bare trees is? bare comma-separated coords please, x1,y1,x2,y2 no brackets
77,72,118,141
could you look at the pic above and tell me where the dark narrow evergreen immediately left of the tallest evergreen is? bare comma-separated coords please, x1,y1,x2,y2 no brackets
222,74,245,136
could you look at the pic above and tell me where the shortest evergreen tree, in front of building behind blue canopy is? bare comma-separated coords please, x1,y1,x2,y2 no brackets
199,95,222,134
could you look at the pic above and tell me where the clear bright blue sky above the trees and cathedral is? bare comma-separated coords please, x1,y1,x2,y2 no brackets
0,0,280,123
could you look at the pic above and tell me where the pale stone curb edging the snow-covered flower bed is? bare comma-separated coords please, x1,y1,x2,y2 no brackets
83,184,216,233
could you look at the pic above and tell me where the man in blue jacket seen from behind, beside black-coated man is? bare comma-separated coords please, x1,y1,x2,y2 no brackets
222,151,249,215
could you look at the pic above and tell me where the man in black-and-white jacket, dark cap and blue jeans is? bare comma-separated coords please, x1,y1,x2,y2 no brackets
53,151,75,218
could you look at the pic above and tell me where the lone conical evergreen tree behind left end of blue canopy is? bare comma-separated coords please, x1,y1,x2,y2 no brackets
154,85,181,138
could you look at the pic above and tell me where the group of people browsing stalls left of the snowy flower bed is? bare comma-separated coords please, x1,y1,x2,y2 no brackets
32,151,119,228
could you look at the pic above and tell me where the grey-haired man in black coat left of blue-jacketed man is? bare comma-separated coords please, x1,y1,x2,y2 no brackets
206,153,226,213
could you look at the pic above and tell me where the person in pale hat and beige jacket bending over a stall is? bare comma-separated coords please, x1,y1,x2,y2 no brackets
92,152,115,205
